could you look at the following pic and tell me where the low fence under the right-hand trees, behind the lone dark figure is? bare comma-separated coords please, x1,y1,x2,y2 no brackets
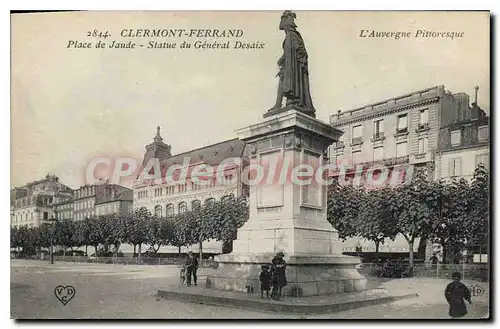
358,263,489,282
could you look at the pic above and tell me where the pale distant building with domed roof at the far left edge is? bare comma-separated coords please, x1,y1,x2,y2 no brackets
10,174,73,227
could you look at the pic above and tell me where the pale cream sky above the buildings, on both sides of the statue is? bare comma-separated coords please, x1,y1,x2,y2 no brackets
11,11,490,188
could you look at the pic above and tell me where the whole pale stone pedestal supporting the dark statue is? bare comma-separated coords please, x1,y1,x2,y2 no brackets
207,107,366,296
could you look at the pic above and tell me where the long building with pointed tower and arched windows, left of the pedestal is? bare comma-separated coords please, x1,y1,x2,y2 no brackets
133,128,248,253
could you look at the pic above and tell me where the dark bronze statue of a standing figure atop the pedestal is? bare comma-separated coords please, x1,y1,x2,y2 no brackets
271,10,315,116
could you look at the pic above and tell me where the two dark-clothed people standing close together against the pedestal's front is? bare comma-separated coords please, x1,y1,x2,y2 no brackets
259,251,287,300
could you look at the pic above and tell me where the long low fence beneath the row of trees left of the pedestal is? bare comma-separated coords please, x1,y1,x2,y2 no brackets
14,256,218,268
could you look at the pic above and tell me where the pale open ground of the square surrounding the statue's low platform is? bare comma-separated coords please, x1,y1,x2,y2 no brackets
11,260,488,319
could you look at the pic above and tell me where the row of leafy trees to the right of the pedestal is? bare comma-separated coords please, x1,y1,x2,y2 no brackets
328,164,489,271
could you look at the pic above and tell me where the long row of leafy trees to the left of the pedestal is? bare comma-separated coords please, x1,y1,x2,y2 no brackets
11,196,248,261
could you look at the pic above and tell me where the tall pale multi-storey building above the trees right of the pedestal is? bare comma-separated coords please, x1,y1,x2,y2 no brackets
329,86,460,181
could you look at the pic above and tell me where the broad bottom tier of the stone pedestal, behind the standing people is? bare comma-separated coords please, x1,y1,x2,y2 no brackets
206,254,367,297
